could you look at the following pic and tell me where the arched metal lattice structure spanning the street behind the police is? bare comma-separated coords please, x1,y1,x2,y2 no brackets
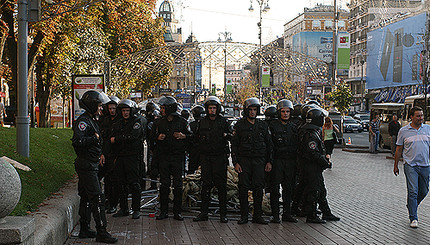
110,42,328,85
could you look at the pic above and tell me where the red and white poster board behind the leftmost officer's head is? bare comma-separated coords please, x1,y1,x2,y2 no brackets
72,75,104,121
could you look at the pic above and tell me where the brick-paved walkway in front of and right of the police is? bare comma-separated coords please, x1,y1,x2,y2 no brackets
66,149,430,244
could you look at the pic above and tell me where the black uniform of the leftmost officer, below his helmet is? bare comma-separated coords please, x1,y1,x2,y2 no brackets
72,112,106,235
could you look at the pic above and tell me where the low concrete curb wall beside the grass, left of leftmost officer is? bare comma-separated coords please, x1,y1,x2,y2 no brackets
30,177,79,244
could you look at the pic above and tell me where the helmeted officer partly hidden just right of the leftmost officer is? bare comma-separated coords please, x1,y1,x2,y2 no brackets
99,95,120,214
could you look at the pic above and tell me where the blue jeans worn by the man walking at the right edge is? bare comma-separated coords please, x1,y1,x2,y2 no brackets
404,164,430,221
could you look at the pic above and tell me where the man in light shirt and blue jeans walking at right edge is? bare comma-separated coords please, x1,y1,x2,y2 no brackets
394,106,430,228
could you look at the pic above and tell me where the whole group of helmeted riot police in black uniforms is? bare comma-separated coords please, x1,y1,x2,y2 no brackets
72,91,339,243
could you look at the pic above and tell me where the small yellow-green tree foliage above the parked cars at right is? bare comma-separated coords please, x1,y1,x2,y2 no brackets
326,81,352,115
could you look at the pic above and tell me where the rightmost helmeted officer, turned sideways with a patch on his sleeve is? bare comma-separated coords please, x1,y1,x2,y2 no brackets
299,108,339,223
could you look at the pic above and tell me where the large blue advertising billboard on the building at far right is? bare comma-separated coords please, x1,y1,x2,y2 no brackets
366,13,427,89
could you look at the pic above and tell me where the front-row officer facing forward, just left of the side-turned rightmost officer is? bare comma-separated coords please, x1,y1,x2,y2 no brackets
269,99,298,223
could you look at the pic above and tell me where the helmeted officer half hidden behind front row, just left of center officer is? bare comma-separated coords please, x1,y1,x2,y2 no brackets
188,105,205,174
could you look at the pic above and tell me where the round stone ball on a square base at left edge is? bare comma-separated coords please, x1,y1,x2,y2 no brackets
0,159,35,244
